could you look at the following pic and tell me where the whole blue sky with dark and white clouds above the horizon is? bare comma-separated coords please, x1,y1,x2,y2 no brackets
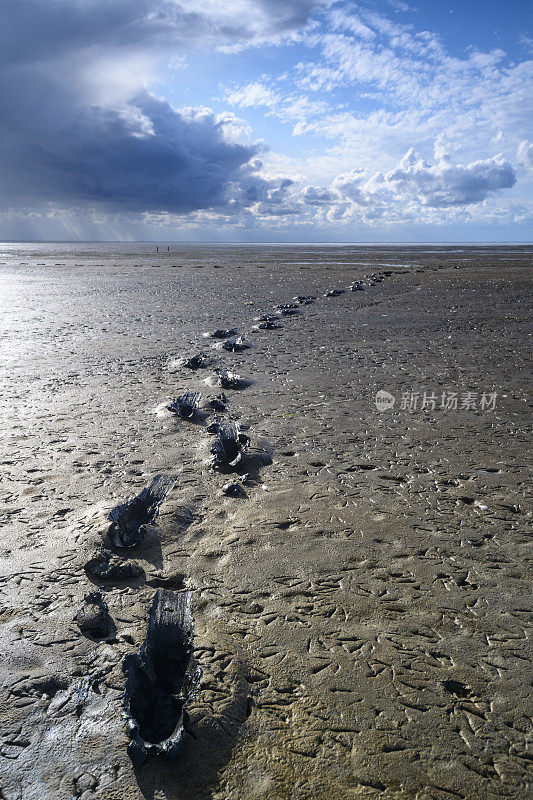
0,0,533,242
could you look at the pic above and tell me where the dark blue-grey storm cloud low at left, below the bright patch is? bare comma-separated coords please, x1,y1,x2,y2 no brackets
0,83,261,213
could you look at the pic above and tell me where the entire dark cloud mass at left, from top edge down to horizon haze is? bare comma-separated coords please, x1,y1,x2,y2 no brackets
0,0,324,213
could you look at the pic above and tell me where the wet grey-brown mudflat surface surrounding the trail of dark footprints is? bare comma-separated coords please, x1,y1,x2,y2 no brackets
0,244,533,800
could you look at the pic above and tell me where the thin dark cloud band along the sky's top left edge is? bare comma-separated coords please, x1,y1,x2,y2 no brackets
0,0,325,63
